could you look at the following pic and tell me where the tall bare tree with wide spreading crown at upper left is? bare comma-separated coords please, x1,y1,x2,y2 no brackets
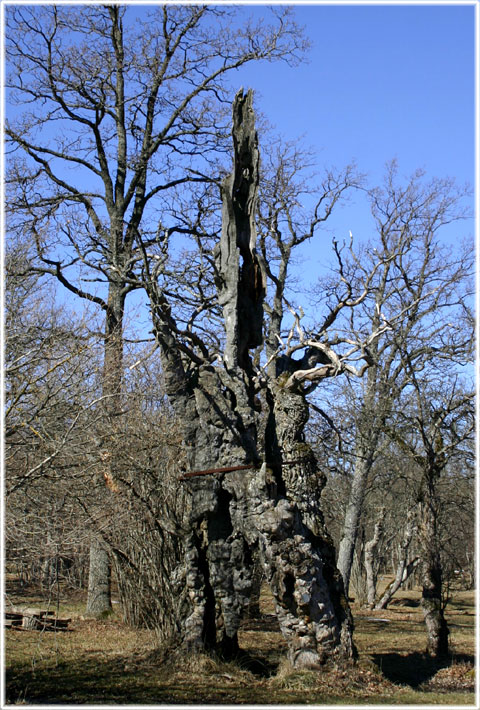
5,5,305,614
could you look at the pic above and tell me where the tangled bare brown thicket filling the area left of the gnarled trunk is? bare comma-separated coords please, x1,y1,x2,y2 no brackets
5,241,188,639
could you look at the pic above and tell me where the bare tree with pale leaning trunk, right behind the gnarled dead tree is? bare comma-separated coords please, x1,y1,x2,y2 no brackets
312,163,472,590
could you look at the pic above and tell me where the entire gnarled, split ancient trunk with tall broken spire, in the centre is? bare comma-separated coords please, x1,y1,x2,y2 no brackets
155,92,355,668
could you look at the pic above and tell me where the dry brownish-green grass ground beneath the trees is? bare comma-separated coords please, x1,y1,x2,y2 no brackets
5,580,475,706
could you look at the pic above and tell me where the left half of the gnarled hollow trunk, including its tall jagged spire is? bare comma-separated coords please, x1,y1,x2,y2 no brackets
172,93,265,656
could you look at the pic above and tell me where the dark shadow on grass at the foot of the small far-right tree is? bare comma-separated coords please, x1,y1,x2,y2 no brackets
372,651,475,689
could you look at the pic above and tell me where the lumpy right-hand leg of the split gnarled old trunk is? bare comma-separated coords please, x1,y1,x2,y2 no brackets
256,384,356,668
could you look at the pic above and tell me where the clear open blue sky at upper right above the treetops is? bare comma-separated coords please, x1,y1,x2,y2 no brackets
230,3,475,290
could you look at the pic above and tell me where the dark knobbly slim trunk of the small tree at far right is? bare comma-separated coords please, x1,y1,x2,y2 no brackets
420,482,449,659
